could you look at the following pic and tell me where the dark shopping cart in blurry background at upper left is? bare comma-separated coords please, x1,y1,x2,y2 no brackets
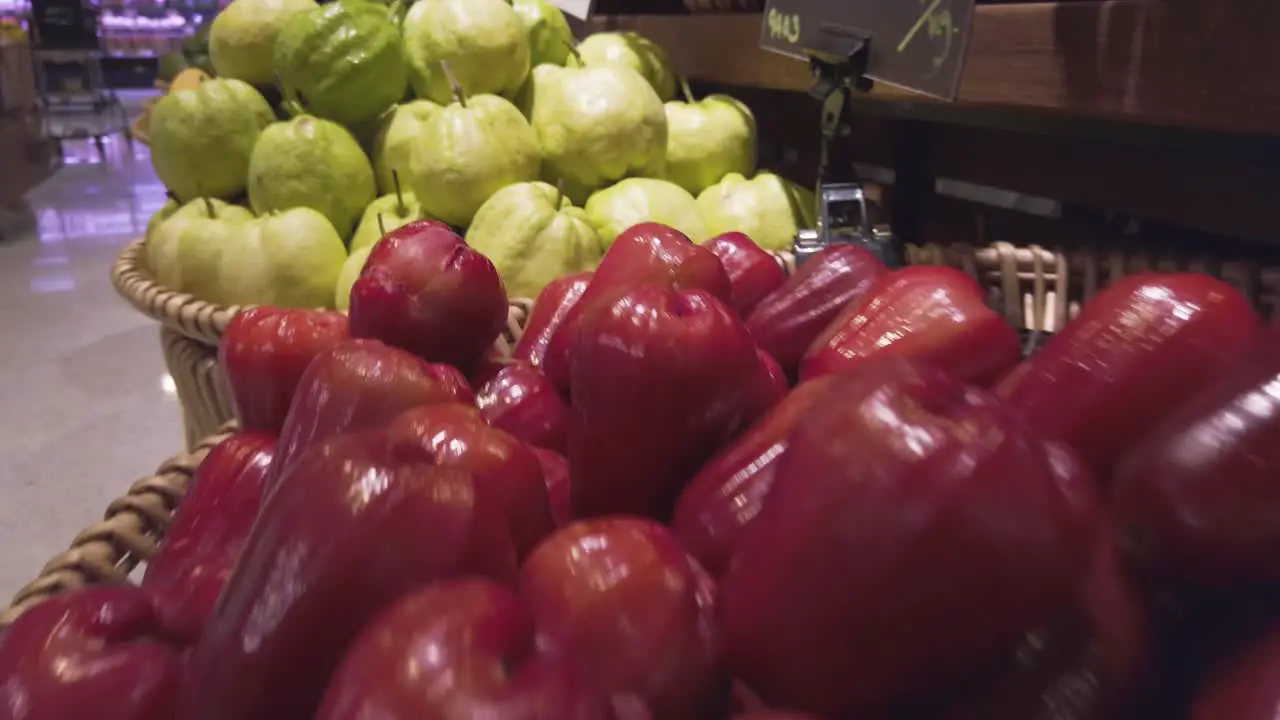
31,0,133,160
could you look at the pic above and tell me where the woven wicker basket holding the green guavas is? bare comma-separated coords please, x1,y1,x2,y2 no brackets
111,240,532,447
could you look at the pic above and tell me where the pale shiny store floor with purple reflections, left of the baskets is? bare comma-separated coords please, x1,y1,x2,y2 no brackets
0,101,182,594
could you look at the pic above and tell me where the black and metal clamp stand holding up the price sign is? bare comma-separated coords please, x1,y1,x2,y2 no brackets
795,27,904,268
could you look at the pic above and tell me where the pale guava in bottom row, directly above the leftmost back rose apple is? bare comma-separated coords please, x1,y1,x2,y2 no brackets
218,208,347,307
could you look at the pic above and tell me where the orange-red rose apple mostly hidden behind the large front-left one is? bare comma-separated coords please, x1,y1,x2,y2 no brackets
387,404,556,557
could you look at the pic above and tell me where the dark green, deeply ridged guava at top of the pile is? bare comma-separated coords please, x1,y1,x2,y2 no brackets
273,3,408,126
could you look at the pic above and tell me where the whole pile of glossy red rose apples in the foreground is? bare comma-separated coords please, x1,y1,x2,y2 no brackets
0,222,1280,720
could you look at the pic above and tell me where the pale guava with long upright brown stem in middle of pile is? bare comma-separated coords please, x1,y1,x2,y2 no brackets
408,92,540,227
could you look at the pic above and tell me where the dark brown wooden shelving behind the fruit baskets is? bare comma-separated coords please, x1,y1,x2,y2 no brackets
590,0,1280,251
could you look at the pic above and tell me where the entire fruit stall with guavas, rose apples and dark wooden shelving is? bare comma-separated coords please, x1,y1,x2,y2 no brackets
0,0,1280,720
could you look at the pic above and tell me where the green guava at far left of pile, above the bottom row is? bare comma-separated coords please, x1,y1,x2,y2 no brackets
150,79,275,201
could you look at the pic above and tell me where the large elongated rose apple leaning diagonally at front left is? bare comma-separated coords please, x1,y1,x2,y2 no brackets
179,430,516,720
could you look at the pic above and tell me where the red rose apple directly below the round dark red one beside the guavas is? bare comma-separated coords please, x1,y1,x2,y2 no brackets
268,340,475,488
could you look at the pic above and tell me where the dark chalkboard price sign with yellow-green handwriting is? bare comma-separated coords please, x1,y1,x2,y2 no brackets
760,0,974,100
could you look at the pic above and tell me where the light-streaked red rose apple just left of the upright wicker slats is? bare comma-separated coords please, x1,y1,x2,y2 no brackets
800,265,1021,386
